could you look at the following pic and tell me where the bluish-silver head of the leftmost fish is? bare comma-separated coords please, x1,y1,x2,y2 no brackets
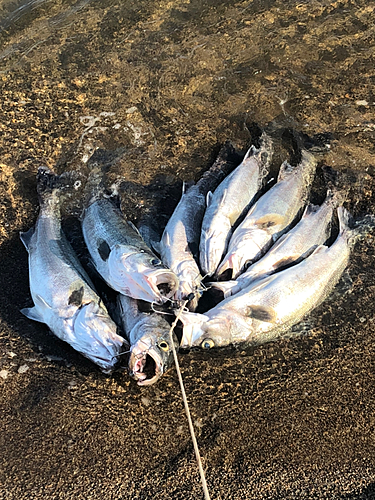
69,302,126,373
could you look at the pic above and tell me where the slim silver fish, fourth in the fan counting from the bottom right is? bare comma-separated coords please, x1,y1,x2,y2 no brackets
199,133,272,276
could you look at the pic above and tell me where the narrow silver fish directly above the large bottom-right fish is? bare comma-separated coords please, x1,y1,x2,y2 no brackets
210,188,342,297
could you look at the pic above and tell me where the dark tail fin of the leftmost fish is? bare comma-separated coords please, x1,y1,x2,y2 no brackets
36,167,82,208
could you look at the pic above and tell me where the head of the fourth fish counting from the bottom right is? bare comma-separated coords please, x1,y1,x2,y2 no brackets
199,218,231,276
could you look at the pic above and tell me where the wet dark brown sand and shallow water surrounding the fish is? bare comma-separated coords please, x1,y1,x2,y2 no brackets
0,0,375,500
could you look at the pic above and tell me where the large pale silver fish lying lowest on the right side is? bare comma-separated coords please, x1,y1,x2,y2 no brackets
180,207,360,349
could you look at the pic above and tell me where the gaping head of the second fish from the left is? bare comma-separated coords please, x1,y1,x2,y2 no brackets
108,245,179,304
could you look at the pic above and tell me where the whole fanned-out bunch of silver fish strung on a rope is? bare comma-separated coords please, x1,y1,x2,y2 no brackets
21,134,370,385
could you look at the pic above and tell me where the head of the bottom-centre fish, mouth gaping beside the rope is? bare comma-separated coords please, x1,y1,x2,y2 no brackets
129,323,178,386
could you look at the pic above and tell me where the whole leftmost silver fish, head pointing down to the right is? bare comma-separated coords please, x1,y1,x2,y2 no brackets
20,168,126,373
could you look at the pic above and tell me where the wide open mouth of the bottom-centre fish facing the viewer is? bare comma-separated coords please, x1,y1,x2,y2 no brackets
129,347,164,386
